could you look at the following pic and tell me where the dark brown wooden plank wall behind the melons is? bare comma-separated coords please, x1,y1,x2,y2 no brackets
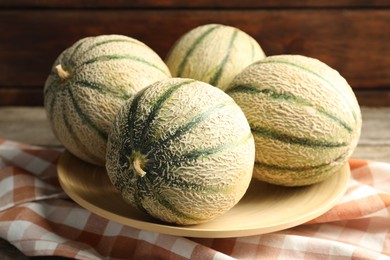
0,0,390,106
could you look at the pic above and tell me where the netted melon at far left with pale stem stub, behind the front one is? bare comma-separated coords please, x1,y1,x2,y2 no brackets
44,35,171,166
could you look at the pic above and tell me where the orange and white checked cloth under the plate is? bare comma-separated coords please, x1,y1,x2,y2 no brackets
0,139,390,260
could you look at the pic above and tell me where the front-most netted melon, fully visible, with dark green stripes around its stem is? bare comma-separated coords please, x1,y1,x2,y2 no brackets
106,78,255,225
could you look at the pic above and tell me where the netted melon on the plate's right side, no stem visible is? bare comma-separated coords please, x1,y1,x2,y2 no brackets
226,55,362,186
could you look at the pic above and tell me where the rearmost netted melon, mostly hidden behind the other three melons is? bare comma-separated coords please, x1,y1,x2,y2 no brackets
165,24,265,90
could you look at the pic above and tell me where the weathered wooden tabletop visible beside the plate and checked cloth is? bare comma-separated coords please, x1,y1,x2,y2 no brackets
0,107,390,259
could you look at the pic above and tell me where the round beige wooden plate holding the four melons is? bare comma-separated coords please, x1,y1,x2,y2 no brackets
58,152,350,238
